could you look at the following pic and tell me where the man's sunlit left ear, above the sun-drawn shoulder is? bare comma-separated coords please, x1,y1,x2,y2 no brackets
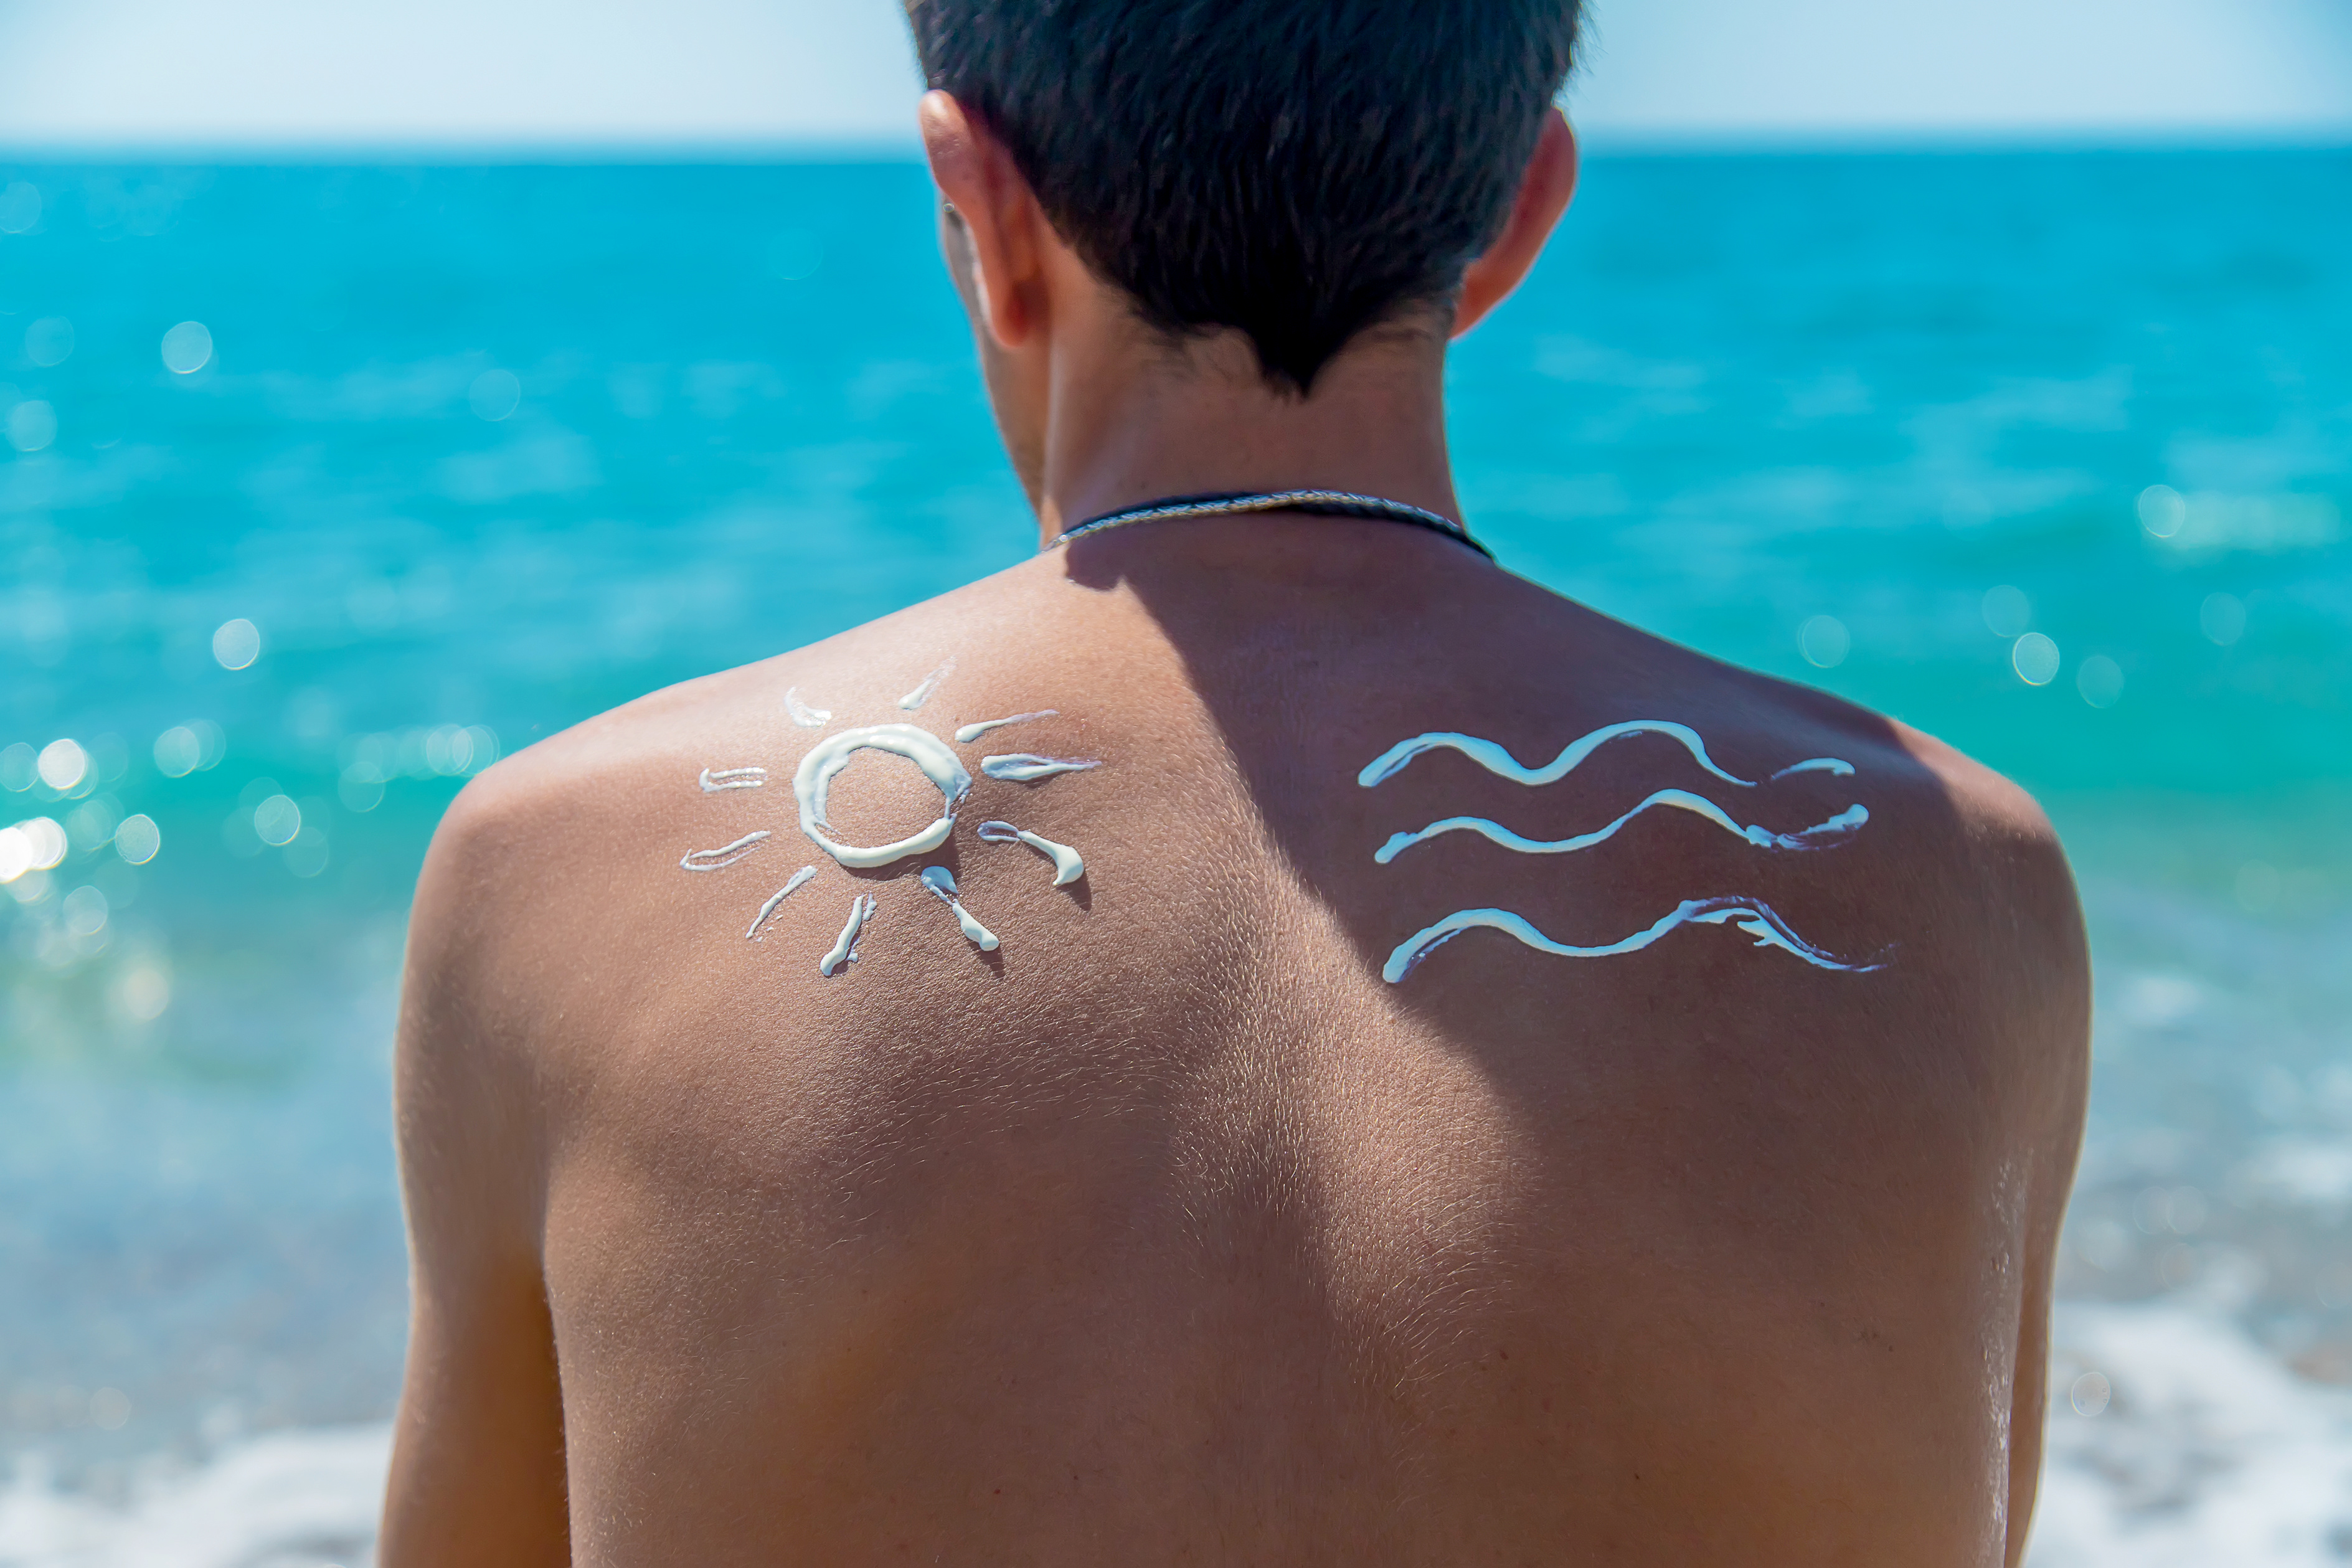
917,92,1044,348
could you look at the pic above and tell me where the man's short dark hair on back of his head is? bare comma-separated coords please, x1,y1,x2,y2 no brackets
905,0,1580,395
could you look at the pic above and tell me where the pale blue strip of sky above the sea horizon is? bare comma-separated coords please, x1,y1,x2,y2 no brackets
0,0,2352,155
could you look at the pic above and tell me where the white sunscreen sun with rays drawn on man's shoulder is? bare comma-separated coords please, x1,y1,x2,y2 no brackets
678,658,1101,980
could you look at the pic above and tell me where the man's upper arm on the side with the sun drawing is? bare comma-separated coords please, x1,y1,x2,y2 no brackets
379,776,569,1568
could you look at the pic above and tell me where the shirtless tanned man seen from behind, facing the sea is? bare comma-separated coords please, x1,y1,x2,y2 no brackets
381,0,2089,1568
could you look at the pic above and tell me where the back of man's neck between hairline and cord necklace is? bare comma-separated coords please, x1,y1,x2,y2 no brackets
1037,314,1461,543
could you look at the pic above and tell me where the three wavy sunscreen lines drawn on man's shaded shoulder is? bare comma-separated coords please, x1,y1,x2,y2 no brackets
1355,719,1884,985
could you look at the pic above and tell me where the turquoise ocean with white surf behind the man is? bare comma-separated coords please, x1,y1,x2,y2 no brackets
0,151,2352,1568
